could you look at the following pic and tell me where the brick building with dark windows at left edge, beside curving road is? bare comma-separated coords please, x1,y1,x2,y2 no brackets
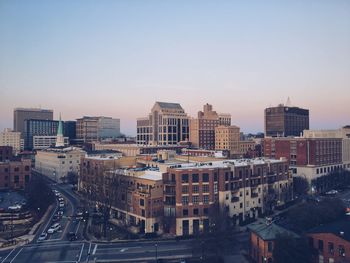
0,159,31,190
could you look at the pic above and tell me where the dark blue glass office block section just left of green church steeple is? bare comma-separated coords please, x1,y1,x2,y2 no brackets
23,120,58,150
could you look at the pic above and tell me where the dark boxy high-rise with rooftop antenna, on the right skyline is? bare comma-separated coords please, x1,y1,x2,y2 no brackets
265,104,309,137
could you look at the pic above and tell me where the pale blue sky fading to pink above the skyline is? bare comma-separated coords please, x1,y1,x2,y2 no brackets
0,0,350,135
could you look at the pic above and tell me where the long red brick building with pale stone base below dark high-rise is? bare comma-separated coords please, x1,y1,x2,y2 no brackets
263,137,343,181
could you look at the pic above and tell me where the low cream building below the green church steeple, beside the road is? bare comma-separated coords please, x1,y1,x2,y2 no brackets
35,147,85,182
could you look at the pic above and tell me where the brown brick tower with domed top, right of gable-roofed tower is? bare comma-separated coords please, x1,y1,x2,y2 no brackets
190,103,231,150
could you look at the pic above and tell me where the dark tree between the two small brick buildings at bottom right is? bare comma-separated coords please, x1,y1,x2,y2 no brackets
273,235,312,263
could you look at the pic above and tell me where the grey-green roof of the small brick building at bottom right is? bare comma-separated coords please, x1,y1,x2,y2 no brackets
248,222,299,241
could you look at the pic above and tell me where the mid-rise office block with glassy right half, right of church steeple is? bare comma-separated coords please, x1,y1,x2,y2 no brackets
76,116,120,142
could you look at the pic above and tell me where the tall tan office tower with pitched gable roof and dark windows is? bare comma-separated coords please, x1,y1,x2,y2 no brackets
137,101,189,145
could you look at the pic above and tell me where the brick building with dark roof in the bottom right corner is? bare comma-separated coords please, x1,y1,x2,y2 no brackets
307,219,350,263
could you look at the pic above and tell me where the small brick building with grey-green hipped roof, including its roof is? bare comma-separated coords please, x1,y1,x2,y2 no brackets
248,222,298,263
